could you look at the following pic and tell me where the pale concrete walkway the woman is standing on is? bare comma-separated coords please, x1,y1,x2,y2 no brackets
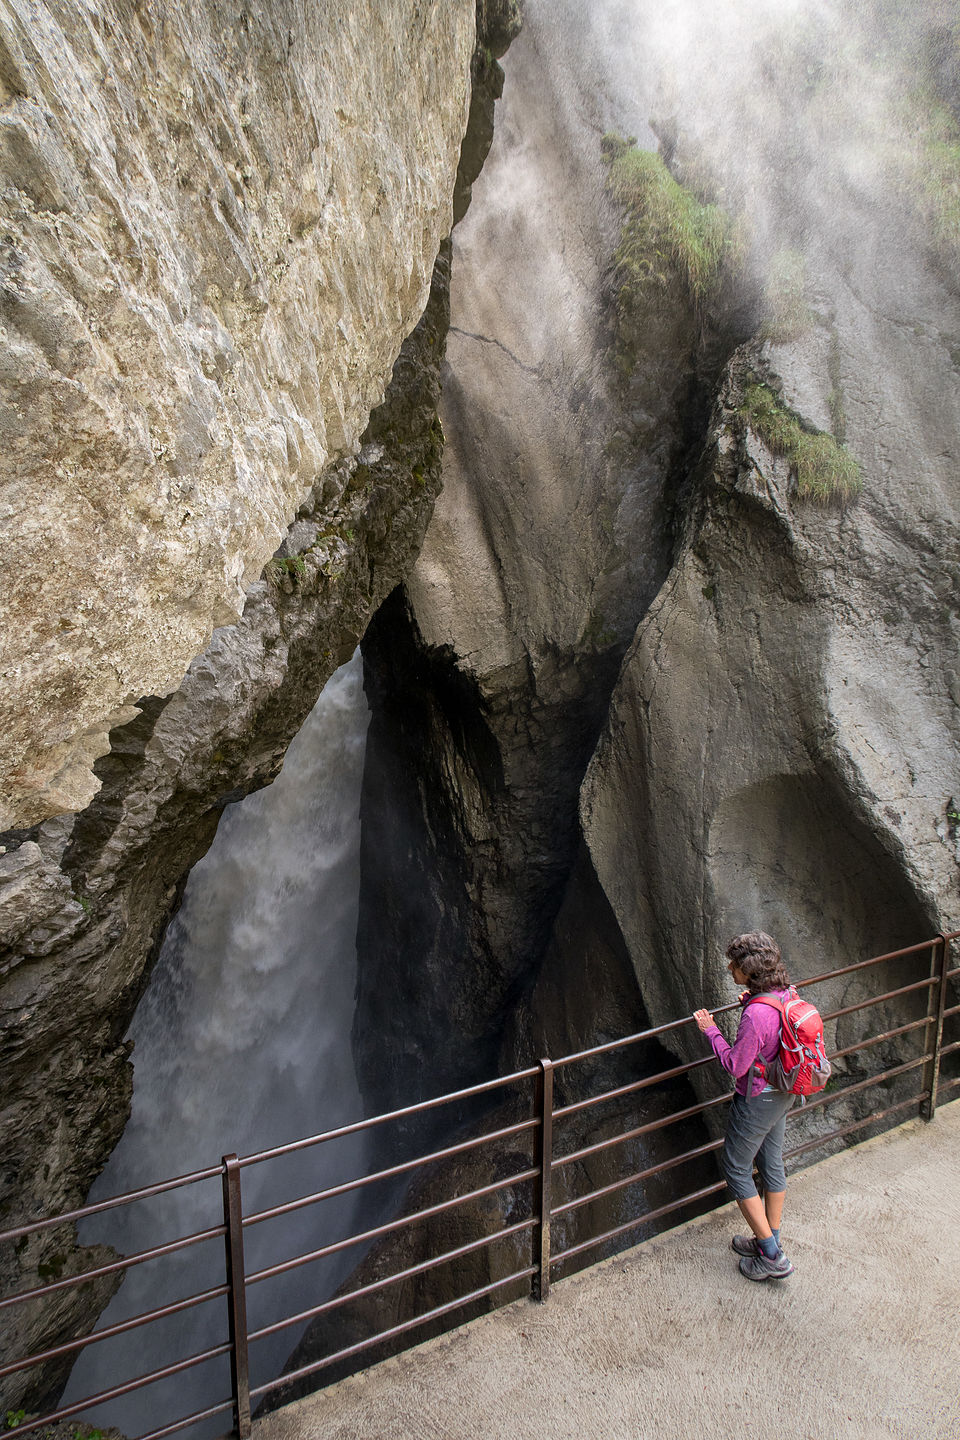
253,1102,960,1440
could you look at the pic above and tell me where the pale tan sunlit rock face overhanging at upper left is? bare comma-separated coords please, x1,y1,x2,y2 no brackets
0,0,475,828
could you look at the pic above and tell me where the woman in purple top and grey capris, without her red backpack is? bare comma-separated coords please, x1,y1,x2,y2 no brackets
694,930,794,1280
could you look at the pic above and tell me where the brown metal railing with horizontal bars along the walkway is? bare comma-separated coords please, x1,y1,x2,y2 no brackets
0,932,960,1440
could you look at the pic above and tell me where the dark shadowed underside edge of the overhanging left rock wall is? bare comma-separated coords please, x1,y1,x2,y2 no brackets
0,6,495,1407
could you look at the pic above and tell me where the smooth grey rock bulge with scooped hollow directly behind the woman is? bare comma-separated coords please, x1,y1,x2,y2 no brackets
581,321,960,1044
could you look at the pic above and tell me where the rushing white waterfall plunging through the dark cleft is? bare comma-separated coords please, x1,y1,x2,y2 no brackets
65,654,368,1436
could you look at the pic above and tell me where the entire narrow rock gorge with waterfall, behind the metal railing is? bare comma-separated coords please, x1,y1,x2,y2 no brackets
0,0,960,1436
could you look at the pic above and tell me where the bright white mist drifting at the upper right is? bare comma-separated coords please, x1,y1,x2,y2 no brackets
569,0,960,279
